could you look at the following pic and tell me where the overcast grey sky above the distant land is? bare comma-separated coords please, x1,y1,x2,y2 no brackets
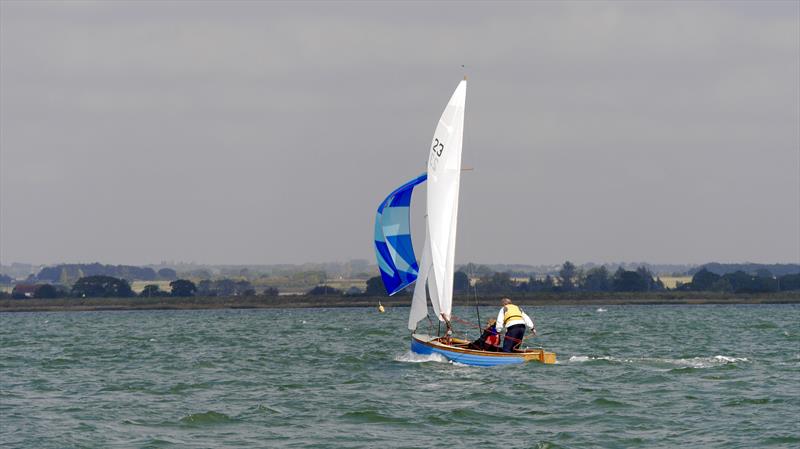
0,0,800,264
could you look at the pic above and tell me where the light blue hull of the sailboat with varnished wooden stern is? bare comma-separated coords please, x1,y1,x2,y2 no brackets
411,334,556,366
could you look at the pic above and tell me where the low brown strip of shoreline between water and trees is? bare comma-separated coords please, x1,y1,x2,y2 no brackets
0,291,800,313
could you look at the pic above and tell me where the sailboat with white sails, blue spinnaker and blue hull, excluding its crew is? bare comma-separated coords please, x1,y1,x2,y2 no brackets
375,77,556,366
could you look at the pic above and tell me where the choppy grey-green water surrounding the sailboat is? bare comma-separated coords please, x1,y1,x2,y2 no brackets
0,305,800,448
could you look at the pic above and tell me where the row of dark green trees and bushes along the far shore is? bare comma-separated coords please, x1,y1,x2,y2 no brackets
0,261,800,299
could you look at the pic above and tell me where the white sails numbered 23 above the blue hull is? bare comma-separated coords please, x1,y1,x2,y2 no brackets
408,79,467,330
